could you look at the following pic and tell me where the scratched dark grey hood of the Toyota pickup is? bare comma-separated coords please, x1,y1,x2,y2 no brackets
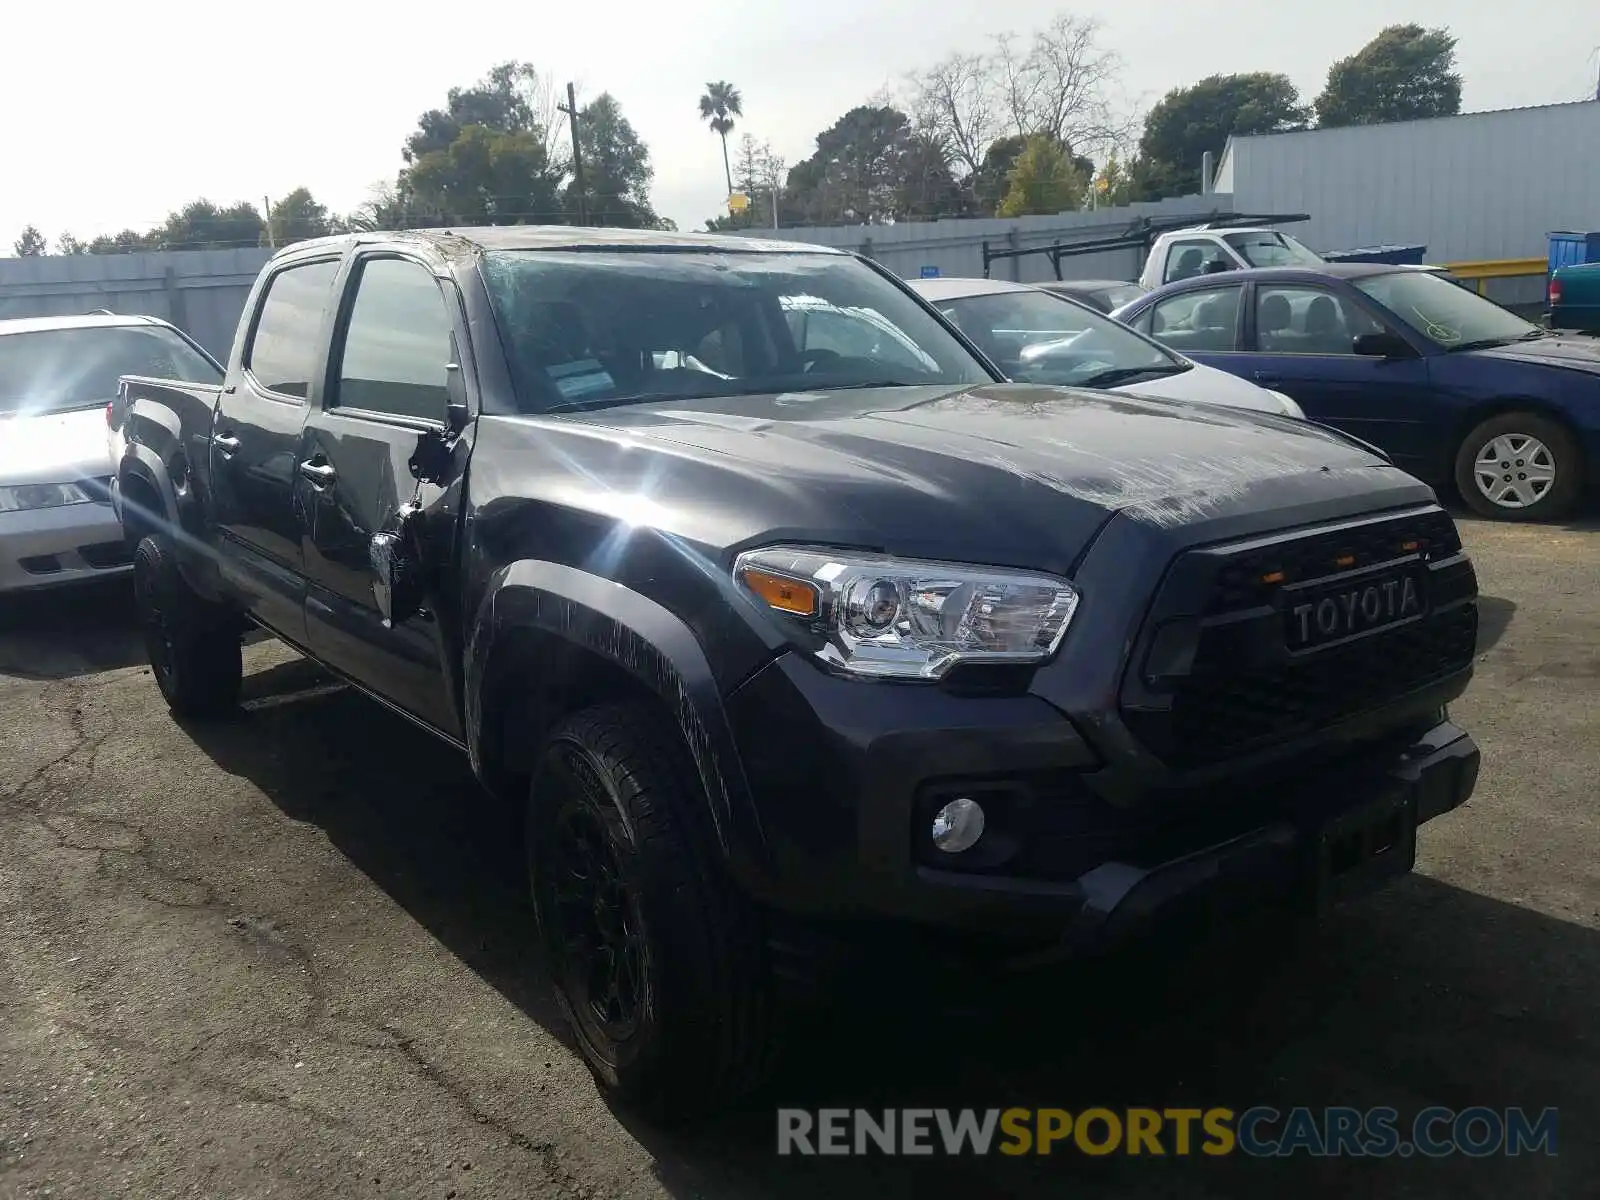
474,384,1430,570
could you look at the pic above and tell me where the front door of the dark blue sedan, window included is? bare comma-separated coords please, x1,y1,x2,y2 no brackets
1251,283,1440,478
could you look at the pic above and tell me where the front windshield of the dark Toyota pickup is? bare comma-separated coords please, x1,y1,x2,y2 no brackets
483,250,992,413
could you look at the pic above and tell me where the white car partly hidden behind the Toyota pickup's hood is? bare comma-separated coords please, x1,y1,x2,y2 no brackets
906,278,1306,419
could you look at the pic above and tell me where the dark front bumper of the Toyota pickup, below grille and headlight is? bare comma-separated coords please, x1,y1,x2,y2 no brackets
730,656,1478,957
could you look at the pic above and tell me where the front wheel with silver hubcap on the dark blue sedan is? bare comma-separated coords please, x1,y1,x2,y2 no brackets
1456,413,1584,522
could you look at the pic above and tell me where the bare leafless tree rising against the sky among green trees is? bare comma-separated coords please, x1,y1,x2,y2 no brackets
909,13,1128,186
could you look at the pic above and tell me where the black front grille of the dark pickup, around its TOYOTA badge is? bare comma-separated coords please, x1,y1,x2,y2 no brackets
1123,512,1478,768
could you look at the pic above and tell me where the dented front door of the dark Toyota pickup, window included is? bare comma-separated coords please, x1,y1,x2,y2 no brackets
296,254,461,738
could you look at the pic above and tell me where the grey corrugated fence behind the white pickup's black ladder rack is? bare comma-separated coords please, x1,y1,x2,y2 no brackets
732,195,1234,283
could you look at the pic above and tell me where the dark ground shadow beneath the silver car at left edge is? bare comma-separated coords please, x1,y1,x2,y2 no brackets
0,576,144,680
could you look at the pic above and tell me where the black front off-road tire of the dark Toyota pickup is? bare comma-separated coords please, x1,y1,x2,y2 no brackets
526,704,773,1120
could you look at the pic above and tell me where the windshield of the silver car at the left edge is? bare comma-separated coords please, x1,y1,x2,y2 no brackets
0,325,222,416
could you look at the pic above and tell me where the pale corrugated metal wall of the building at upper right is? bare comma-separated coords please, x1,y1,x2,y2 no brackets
1218,101,1600,262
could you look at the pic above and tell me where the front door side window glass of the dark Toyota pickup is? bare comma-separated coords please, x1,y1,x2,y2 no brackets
333,258,451,421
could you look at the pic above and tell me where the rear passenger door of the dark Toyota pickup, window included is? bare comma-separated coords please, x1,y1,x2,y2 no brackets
210,256,339,645
